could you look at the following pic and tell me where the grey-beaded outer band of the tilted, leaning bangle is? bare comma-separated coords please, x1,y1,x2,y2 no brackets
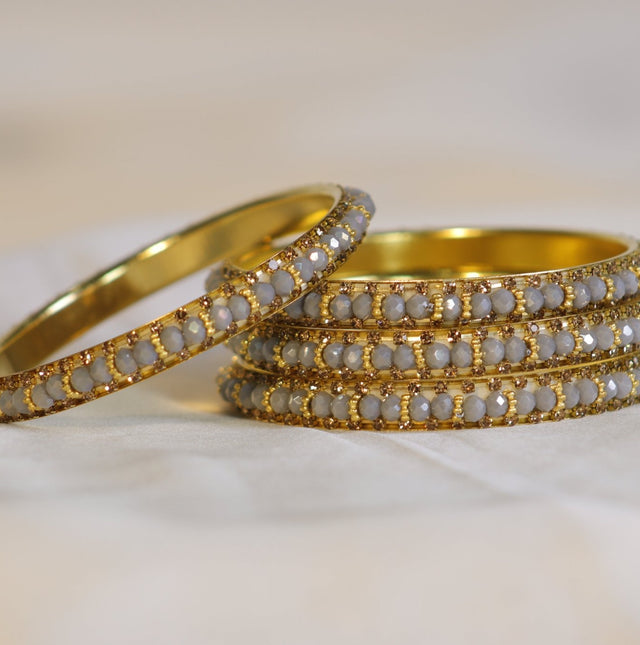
0,189,373,422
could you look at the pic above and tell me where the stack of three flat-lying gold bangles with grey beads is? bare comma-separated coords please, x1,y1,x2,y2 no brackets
218,229,640,430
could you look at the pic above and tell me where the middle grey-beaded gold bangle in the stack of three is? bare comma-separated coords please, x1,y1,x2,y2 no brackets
229,297,640,380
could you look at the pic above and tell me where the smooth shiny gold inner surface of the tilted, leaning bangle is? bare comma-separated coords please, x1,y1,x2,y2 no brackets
0,185,341,374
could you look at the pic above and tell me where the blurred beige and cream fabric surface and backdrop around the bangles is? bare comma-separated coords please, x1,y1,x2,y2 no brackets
0,0,640,645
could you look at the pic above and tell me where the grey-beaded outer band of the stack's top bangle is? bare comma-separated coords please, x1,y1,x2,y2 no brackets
281,266,639,327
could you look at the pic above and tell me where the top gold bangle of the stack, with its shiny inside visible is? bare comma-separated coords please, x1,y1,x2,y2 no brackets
215,228,640,329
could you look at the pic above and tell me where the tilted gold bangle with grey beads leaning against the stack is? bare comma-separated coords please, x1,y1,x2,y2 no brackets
0,184,373,422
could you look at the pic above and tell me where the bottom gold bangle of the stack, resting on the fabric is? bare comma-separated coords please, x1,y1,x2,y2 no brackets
218,351,640,430
